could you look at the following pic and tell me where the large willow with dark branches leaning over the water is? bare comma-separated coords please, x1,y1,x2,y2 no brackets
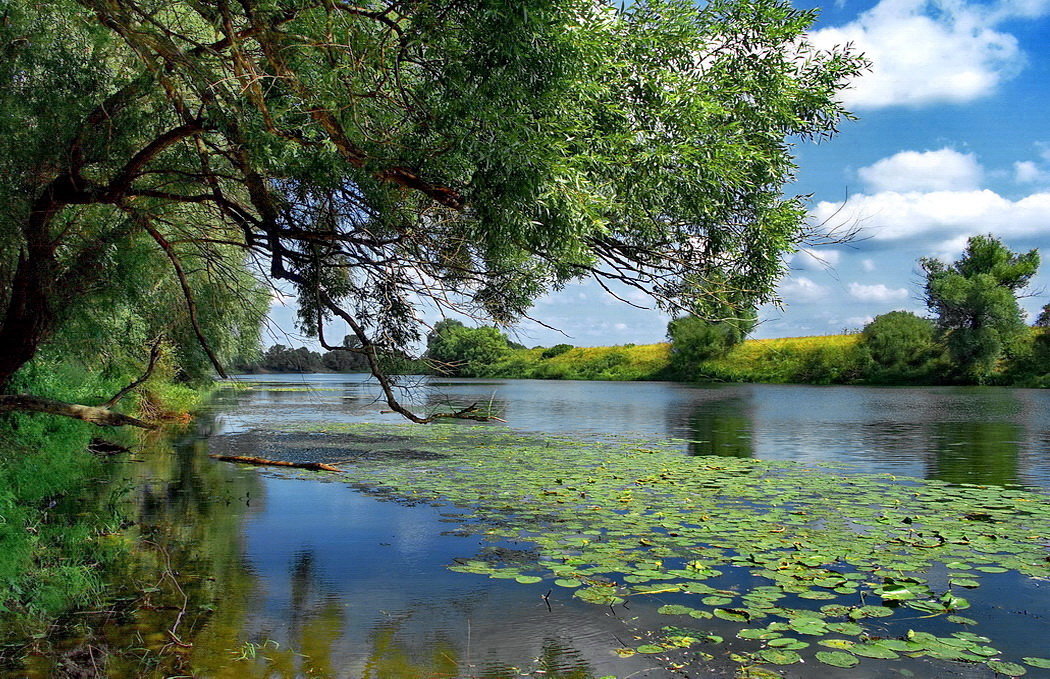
0,0,864,421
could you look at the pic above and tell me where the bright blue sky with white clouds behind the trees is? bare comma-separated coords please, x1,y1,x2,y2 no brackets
265,0,1050,346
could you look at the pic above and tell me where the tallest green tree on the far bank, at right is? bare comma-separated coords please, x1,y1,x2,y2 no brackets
920,234,1040,383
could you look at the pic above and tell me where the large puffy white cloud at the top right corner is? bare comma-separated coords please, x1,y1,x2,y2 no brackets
811,0,1029,108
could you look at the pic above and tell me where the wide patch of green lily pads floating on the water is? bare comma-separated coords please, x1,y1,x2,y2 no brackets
273,425,1050,676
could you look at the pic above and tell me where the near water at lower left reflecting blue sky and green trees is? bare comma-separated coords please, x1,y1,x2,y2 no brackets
8,413,638,679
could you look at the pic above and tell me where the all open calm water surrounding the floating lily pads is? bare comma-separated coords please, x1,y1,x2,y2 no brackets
6,375,1050,679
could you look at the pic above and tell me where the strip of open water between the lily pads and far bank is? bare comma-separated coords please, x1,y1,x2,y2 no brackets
219,375,1050,489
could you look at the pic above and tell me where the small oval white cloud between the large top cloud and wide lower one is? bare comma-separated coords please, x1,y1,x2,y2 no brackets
857,148,983,192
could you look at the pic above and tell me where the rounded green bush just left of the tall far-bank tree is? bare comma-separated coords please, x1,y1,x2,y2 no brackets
861,311,941,382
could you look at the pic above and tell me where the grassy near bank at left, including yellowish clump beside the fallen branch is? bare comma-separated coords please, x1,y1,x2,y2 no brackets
0,359,207,636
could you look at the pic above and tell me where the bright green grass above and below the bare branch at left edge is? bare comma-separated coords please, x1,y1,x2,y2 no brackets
0,356,143,634
